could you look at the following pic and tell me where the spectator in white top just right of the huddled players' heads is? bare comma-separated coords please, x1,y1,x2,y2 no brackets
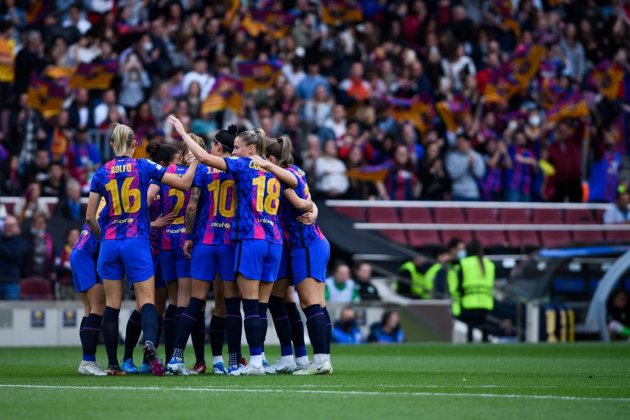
315,140,349,197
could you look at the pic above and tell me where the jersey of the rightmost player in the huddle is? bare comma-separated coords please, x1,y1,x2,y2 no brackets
280,165,325,249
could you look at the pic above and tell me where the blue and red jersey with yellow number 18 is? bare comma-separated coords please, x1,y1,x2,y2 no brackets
225,157,283,244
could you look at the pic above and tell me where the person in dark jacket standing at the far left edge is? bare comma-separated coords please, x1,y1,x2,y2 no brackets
0,215,28,300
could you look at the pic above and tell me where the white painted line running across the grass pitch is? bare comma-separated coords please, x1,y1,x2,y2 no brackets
0,384,630,403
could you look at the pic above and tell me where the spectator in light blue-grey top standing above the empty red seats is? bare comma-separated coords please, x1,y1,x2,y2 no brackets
446,134,485,201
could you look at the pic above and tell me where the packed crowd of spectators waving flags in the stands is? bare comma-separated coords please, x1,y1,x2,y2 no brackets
0,0,630,298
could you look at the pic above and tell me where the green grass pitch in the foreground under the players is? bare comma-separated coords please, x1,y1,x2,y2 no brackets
0,343,630,420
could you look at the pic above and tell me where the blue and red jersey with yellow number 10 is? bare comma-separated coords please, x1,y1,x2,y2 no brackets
189,162,236,245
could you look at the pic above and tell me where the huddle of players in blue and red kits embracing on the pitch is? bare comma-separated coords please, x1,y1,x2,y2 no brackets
71,116,332,376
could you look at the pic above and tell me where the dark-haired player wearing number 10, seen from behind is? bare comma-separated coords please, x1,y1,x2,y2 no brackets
167,126,243,375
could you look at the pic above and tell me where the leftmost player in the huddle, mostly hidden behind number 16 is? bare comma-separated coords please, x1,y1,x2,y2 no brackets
70,200,108,376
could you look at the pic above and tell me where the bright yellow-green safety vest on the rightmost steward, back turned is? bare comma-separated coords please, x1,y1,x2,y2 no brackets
459,256,494,311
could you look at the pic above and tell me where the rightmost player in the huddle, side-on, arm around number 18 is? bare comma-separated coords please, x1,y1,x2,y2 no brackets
260,137,332,375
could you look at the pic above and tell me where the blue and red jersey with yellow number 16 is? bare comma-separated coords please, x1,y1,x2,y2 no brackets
90,157,165,241
